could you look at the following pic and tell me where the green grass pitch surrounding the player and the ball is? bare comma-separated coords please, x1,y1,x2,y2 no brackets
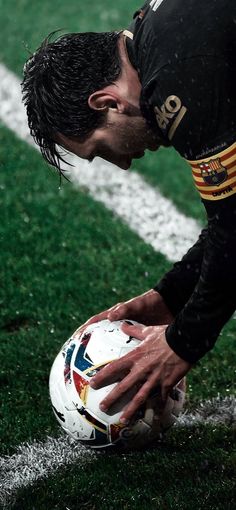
0,0,236,510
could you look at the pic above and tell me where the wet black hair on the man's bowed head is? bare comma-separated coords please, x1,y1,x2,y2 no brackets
22,32,121,171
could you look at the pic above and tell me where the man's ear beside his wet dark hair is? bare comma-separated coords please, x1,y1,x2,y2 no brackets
88,90,125,113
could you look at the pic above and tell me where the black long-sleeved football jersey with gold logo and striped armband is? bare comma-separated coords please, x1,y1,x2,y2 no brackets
126,0,236,363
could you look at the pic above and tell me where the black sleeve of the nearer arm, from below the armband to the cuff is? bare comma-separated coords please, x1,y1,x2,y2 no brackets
166,191,236,363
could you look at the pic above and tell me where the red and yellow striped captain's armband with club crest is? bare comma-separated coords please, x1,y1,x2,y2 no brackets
187,143,236,200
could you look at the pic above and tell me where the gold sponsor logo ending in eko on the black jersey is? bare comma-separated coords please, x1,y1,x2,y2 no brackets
154,95,187,140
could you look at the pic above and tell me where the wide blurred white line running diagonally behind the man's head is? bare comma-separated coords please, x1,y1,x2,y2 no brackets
0,64,200,261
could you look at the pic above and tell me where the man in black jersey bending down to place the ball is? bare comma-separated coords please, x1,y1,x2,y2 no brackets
23,0,236,423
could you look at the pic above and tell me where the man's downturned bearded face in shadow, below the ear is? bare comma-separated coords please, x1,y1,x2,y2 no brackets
58,109,160,170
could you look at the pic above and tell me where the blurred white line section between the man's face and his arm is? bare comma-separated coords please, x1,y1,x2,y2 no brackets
68,156,200,261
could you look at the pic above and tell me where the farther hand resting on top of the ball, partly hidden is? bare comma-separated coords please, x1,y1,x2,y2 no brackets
78,289,174,333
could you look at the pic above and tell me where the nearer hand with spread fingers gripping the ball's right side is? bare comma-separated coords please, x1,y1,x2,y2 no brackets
90,323,192,424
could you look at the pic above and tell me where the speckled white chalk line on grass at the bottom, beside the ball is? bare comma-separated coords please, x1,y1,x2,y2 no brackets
0,396,236,508
